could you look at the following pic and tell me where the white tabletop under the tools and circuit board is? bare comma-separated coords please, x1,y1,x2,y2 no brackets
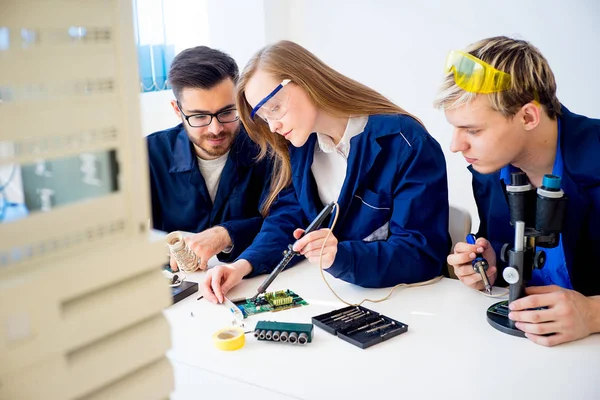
165,261,600,400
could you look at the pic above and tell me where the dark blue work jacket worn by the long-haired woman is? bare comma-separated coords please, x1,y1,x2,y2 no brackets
240,115,450,287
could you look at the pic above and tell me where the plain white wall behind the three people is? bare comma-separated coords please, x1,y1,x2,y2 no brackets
142,0,600,228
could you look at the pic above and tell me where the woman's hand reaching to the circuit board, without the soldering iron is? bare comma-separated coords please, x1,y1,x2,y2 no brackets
201,259,252,303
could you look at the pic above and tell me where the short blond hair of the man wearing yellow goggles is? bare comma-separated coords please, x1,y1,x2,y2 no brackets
434,36,560,119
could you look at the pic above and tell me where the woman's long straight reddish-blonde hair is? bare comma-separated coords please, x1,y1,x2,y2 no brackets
236,40,422,215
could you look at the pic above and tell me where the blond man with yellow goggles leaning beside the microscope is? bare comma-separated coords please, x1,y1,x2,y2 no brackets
435,36,600,346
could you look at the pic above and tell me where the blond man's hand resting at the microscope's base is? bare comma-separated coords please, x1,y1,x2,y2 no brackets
508,285,600,346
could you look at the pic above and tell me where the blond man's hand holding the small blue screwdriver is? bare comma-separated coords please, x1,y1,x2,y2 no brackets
446,238,498,290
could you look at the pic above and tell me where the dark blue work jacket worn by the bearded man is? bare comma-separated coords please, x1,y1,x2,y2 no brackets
147,124,271,262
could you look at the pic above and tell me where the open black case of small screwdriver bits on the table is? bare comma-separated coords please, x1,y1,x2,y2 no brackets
312,306,408,349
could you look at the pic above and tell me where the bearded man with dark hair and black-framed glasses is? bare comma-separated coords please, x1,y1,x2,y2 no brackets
147,46,271,270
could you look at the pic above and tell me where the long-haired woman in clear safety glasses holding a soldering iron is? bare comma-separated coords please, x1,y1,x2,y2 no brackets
203,41,450,302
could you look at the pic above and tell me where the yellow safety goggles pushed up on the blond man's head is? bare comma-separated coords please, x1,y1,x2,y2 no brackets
446,50,511,93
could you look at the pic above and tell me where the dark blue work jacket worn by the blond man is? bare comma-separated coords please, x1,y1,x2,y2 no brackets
469,106,600,296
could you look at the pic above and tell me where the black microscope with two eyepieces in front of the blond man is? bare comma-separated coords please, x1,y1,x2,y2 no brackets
487,171,567,337
